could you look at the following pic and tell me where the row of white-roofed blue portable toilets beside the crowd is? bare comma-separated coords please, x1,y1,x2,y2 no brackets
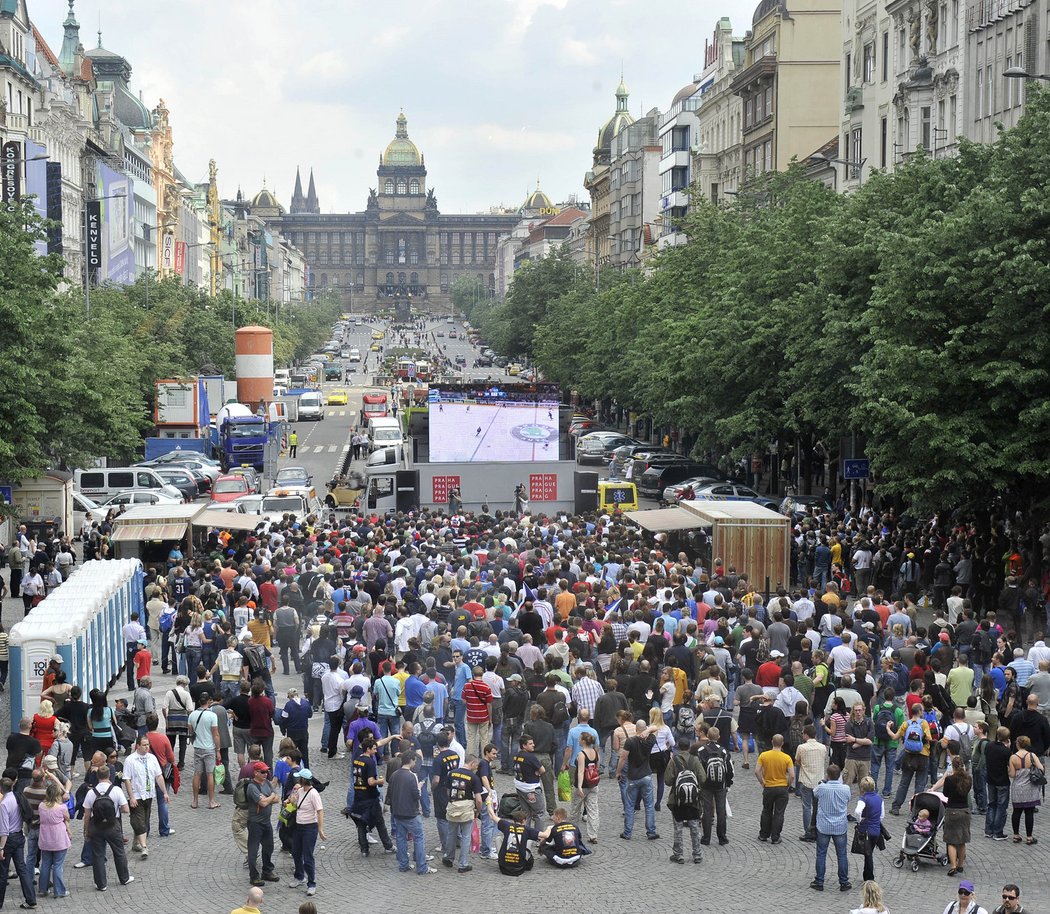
8,559,145,731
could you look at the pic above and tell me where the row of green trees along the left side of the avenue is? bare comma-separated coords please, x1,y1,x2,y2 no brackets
0,201,339,481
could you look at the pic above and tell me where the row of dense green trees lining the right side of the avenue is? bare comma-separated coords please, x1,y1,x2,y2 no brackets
469,91,1050,510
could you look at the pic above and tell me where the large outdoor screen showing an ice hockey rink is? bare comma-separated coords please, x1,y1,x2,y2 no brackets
428,385,561,463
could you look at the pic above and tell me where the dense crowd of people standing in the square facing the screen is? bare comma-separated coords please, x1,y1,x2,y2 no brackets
0,500,1050,914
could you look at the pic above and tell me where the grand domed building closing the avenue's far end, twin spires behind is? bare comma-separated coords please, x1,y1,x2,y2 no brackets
268,112,519,309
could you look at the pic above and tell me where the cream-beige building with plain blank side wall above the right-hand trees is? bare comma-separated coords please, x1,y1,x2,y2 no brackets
732,0,844,179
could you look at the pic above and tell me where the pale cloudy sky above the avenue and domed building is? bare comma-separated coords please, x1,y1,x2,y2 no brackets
27,0,757,213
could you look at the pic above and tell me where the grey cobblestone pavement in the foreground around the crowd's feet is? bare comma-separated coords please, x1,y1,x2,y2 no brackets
0,600,1050,914
